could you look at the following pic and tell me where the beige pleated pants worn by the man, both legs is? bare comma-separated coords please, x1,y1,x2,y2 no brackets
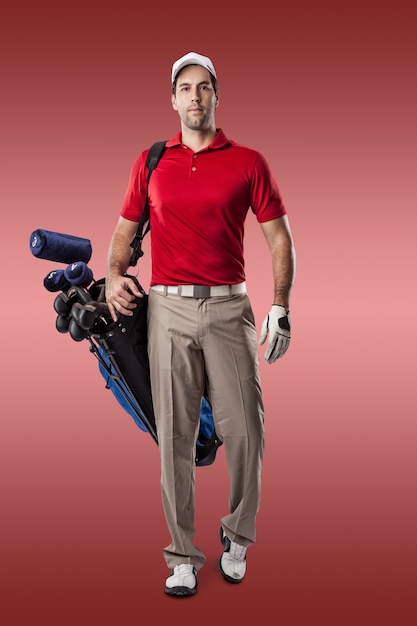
148,290,264,569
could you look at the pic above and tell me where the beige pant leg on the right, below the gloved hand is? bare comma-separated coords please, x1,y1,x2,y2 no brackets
201,295,264,546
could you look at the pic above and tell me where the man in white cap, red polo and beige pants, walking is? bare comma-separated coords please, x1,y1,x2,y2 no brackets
106,52,295,596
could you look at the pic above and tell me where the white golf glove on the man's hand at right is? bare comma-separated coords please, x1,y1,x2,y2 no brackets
259,304,291,363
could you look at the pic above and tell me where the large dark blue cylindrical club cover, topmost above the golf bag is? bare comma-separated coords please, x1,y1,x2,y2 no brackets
30,228,92,263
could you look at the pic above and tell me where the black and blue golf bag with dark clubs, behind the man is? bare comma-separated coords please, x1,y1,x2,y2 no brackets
50,270,221,466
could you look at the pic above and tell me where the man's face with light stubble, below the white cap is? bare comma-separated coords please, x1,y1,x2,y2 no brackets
171,65,219,130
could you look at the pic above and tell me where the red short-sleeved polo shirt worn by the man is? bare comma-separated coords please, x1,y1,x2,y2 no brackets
120,130,286,285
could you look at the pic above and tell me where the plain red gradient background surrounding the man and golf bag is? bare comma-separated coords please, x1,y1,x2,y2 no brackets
0,0,417,626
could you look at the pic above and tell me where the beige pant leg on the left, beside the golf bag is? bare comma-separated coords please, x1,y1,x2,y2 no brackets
148,290,205,569
